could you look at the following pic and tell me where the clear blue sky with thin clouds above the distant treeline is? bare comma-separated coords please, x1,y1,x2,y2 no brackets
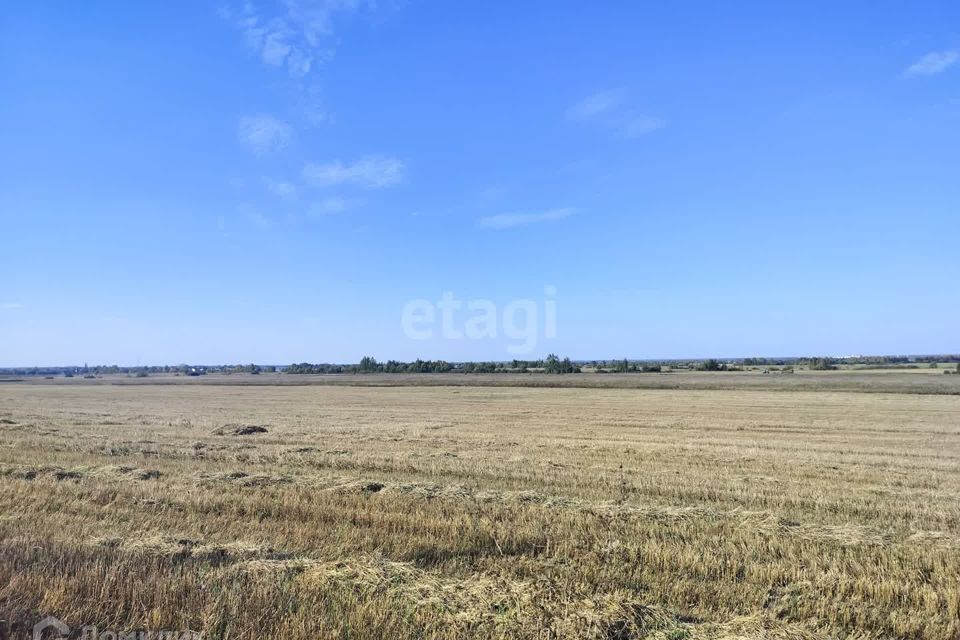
0,0,960,366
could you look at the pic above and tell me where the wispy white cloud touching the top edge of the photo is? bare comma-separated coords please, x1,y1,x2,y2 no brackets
220,0,372,78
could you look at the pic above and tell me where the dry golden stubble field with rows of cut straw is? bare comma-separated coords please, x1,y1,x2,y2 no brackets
0,378,960,640
